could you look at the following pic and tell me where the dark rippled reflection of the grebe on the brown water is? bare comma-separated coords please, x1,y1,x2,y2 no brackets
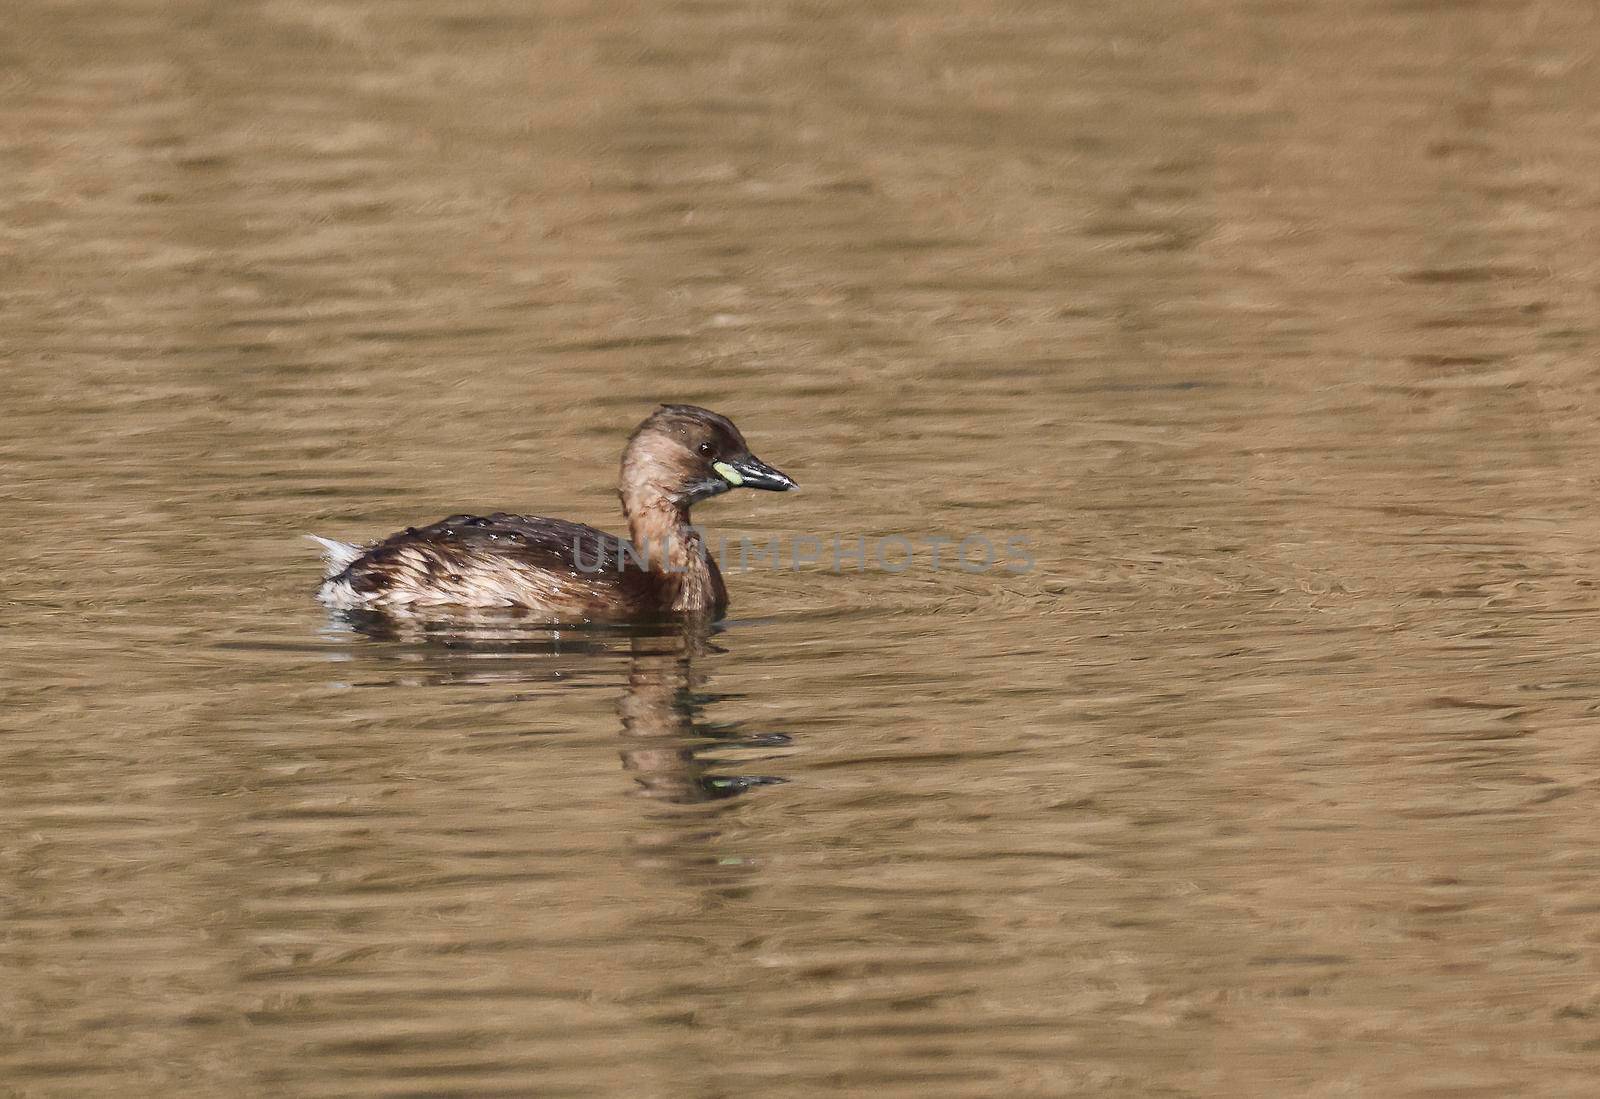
333,609,790,805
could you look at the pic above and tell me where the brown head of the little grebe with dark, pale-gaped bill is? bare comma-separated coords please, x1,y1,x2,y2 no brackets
622,405,800,509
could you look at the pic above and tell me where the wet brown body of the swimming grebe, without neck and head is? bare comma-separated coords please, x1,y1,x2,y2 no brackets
318,512,670,621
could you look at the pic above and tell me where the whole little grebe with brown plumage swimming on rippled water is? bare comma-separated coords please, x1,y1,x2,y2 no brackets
312,405,797,622
